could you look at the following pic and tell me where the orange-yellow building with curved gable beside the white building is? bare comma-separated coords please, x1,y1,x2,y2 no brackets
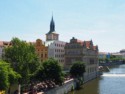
35,39,48,61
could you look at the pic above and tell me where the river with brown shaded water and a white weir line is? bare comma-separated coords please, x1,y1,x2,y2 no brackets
68,65,125,94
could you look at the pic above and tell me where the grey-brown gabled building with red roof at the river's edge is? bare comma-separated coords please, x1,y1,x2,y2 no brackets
65,37,98,81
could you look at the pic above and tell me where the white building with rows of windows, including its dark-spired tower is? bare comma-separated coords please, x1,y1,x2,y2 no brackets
45,17,66,66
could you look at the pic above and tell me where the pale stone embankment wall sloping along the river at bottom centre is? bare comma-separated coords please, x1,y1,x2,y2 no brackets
45,79,76,94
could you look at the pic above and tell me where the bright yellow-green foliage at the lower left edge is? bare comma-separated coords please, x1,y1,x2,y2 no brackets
0,61,21,90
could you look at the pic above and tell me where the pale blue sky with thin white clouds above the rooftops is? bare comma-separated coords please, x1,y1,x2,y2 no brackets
0,0,125,52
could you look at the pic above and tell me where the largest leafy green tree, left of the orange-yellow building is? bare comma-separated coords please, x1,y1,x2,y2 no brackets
4,38,40,83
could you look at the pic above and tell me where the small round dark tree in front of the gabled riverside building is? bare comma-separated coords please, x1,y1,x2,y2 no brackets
70,62,85,77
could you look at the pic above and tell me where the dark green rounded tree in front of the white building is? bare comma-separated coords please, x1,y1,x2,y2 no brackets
43,58,64,85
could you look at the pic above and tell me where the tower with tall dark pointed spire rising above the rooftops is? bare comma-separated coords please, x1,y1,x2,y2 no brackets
46,16,59,41
